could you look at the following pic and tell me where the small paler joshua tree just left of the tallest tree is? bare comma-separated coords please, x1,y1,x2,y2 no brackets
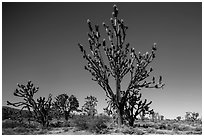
82,96,98,116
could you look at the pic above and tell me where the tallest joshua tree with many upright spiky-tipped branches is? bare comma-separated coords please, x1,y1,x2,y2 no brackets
78,5,164,127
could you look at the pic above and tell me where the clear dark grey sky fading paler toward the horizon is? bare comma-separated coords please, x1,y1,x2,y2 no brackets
2,2,202,118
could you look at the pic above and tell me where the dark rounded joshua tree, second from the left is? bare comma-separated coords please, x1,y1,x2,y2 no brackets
53,94,79,120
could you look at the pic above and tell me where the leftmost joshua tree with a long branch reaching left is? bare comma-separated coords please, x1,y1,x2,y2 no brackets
7,81,52,127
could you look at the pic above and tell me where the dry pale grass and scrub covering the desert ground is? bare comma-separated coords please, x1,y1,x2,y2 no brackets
2,116,202,135
